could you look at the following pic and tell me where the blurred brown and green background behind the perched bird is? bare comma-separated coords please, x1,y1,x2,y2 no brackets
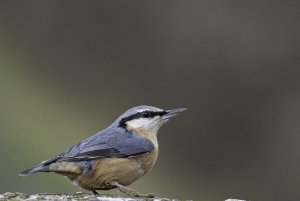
0,0,300,201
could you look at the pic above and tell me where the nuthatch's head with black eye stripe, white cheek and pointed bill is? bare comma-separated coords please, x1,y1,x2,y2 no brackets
116,105,187,134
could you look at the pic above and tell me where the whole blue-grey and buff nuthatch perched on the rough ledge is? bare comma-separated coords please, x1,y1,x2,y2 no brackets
19,105,187,198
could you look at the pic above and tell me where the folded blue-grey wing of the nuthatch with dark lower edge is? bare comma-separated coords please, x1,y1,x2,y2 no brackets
60,127,154,161
